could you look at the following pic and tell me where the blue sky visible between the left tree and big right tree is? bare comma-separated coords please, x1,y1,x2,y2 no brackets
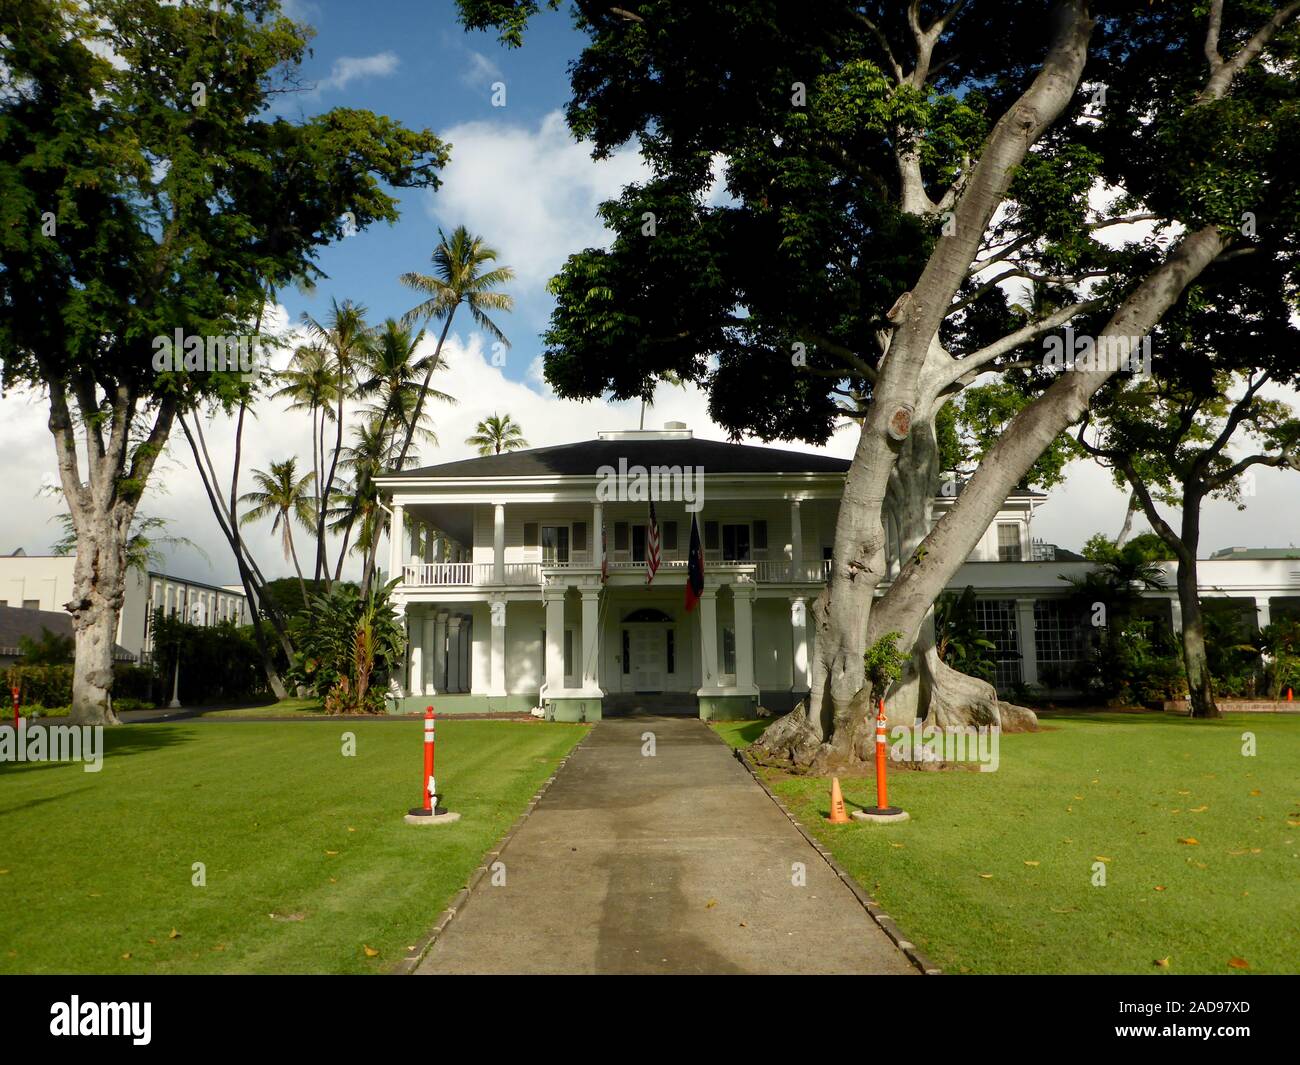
277,0,590,380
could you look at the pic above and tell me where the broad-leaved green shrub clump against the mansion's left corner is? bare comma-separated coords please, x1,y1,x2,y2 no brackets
291,580,406,714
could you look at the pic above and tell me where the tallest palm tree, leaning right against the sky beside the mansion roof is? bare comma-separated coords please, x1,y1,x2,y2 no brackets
398,225,515,469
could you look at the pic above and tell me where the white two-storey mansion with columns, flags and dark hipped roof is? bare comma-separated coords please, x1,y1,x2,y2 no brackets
378,423,1300,720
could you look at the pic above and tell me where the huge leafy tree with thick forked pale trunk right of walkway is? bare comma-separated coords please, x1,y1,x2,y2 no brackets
460,0,1300,765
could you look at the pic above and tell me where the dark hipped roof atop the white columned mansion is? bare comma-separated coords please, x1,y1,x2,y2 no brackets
386,440,849,477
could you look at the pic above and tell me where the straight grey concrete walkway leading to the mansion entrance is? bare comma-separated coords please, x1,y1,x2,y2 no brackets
417,717,917,974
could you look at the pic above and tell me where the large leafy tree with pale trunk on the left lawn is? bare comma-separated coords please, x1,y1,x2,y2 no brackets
0,0,447,723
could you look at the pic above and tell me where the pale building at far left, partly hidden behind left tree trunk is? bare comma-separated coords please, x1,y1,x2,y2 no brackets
0,550,250,659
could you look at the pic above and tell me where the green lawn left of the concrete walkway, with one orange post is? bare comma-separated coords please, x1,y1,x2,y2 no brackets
0,719,585,974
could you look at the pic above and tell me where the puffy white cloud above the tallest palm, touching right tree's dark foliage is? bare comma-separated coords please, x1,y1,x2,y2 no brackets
428,111,649,290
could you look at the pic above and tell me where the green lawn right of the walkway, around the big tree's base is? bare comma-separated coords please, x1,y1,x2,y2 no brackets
718,714,1300,973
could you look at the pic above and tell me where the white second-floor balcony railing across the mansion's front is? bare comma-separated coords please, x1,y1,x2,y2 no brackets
402,553,831,588
